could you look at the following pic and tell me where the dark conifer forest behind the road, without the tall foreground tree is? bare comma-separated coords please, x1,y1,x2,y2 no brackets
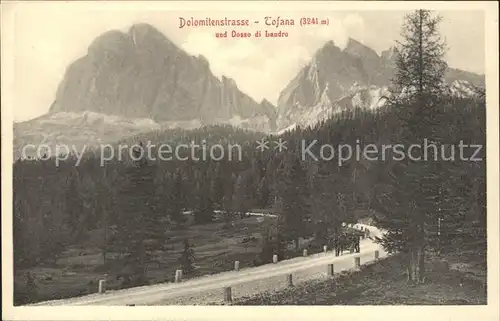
13,98,486,302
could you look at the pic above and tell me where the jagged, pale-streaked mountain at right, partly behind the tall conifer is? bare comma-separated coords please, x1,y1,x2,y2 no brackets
278,39,484,129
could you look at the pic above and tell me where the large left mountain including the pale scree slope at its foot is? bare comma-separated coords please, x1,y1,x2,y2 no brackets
14,24,277,157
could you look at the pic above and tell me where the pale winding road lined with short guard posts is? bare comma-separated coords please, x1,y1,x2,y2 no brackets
33,224,387,306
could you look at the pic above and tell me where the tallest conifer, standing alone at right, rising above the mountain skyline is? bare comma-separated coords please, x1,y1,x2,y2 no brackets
379,10,447,282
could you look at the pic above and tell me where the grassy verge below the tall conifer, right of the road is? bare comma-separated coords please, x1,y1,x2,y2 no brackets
234,249,487,305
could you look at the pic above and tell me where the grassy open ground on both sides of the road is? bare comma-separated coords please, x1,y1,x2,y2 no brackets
15,217,486,305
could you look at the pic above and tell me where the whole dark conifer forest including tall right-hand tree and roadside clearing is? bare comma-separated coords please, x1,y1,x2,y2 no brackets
13,10,487,304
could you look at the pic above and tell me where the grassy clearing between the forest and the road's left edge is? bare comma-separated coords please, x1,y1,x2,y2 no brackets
14,217,272,304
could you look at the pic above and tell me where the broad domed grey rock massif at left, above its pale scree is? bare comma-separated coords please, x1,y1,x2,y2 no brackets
50,24,276,131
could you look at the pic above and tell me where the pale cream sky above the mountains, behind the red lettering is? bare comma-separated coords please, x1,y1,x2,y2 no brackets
3,3,485,121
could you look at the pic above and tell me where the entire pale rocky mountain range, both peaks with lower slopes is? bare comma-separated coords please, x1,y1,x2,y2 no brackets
14,24,484,156
